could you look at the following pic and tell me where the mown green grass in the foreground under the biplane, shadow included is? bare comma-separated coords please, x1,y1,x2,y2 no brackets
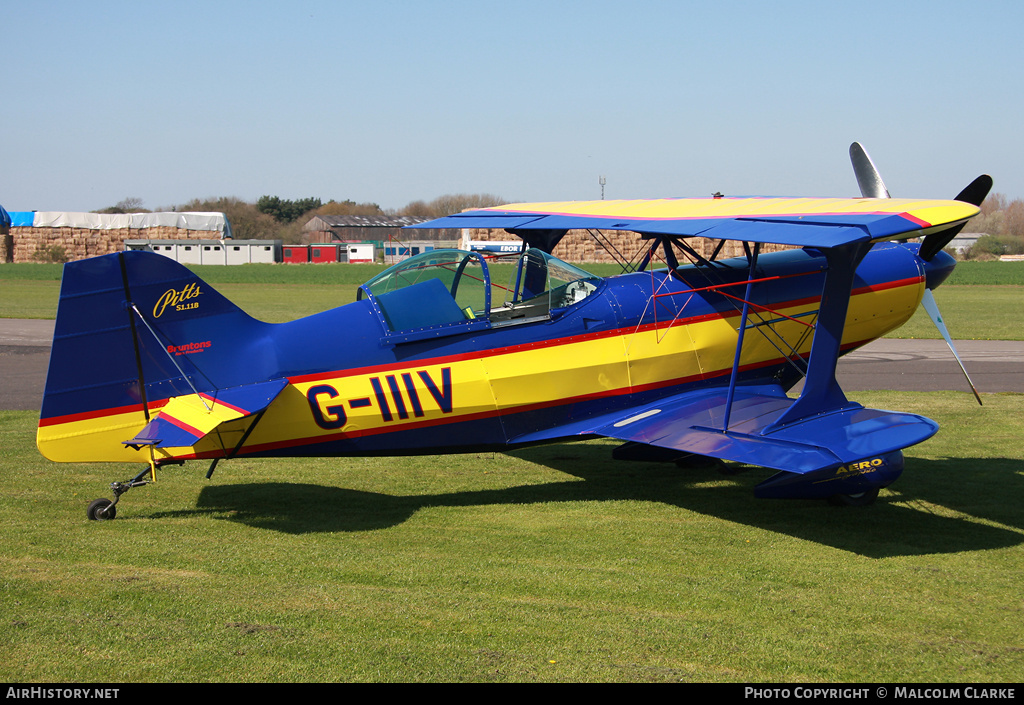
0,392,1024,682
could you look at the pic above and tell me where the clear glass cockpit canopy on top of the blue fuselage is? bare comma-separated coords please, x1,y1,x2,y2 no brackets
358,249,602,342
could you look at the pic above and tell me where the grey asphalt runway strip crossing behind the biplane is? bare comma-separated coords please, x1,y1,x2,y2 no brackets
0,319,1024,411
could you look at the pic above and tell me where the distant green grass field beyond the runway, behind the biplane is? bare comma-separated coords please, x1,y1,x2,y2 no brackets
0,262,1024,340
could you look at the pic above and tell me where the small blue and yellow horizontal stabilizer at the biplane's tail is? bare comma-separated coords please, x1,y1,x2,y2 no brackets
124,379,288,450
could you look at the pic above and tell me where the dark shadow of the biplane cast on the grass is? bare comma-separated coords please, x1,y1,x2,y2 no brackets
178,445,1024,557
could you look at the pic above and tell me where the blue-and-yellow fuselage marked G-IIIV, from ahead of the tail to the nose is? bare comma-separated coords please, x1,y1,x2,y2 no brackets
211,245,937,455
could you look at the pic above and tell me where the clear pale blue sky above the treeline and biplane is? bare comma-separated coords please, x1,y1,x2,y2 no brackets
0,0,1024,211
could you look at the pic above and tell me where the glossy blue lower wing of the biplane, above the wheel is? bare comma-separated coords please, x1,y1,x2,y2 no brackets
591,386,938,474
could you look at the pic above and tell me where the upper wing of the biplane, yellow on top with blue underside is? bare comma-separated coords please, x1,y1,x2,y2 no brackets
403,198,979,248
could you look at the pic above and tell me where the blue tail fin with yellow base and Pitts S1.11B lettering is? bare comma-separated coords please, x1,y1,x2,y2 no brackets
37,251,275,461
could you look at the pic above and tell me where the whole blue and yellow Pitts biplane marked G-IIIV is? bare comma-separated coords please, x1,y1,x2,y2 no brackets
37,143,991,520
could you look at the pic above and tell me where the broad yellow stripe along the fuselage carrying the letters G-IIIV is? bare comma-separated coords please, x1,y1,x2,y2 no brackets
37,281,924,462
